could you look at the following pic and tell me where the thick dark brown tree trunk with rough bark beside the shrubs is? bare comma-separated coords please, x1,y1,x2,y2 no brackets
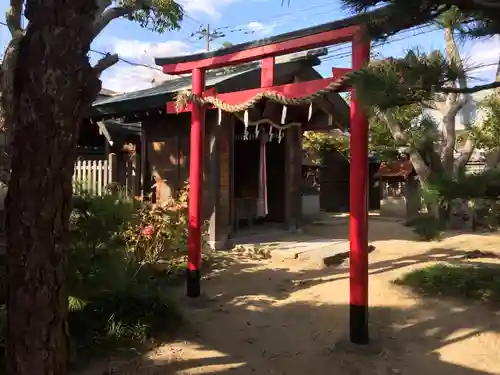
6,0,100,375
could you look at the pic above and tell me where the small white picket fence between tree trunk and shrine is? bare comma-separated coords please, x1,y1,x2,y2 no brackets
73,160,113,195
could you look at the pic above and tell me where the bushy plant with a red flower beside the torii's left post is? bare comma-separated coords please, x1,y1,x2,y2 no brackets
123,184,206,264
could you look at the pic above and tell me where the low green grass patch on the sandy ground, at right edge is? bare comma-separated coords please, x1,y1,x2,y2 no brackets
395,264,500,306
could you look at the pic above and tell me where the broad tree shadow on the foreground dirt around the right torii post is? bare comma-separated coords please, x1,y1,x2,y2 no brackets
149,301,500,375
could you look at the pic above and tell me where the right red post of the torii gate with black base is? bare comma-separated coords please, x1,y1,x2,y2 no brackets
349,33,370,345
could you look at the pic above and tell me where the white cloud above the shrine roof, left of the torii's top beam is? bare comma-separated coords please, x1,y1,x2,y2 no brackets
101,38,191,92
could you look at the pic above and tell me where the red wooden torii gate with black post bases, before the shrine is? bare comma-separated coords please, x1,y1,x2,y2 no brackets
156,17,370,344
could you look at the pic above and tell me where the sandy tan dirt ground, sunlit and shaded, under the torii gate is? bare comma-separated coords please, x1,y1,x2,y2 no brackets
78,219,500,375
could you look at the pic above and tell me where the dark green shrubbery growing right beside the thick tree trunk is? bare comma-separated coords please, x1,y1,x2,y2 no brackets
67,191,179,351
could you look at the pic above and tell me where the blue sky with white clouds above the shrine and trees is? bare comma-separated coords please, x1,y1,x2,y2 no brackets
0,0,500,92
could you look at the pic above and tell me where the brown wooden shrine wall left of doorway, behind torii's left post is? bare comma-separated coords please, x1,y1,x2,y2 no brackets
143,111,234,248
